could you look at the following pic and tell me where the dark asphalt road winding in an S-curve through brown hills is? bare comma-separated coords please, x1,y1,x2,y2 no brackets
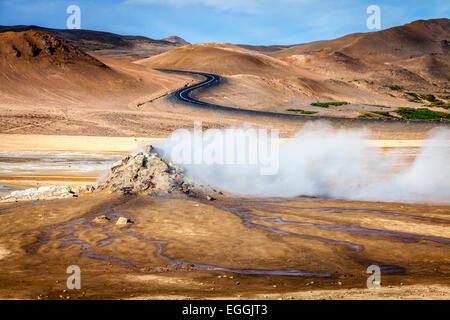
155,69,446,125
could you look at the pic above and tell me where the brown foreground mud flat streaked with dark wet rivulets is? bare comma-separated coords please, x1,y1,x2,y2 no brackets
0,192,450,299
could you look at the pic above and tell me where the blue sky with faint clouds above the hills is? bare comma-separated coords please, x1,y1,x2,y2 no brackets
0,0,450,45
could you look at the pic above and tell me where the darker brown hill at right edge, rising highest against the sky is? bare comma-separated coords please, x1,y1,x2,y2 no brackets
271,19,450,94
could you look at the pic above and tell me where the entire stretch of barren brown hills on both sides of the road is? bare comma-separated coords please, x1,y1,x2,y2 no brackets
0,19,449,135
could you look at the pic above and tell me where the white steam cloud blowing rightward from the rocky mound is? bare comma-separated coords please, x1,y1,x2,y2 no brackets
158,123,450,204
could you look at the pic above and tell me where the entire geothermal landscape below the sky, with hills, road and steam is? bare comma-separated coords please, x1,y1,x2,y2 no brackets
0,18,450,300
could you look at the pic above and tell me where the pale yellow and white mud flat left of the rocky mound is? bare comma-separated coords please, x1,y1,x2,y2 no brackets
0,134,159,189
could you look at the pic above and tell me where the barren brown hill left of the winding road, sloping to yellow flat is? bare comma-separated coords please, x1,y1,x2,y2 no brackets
0,30,197,135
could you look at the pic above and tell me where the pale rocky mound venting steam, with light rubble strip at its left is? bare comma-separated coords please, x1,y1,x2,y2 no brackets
0,146,222,202
